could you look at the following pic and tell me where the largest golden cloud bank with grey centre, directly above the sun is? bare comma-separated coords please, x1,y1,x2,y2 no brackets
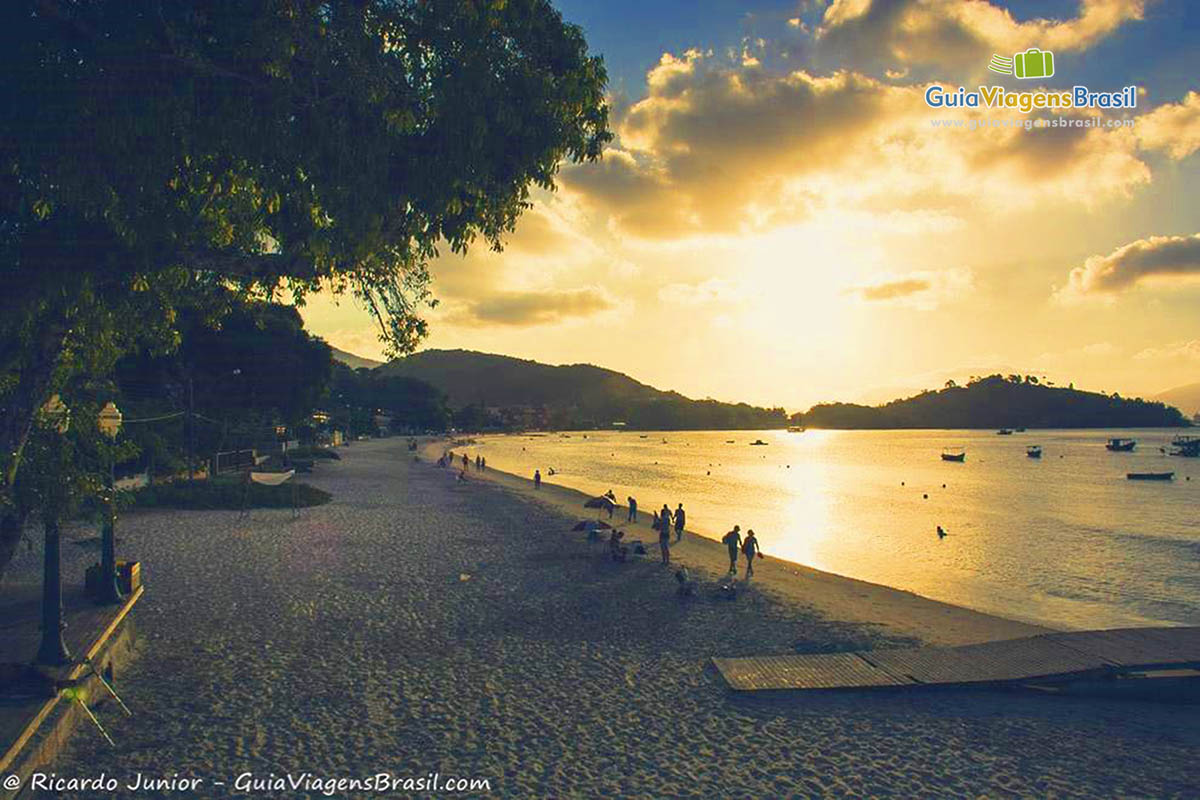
562,50,1151,239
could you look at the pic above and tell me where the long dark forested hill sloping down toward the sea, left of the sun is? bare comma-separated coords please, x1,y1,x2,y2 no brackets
379,350,787,431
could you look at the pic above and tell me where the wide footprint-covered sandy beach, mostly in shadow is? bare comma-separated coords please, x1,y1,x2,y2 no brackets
13,439,1200,798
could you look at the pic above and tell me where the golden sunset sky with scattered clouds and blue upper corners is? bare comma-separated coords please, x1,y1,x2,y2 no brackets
305,0,1200,410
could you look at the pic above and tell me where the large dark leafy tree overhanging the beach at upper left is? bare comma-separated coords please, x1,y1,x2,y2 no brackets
0,0,610,569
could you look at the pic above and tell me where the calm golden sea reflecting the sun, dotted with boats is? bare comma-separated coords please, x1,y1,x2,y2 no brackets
470,429,1200,628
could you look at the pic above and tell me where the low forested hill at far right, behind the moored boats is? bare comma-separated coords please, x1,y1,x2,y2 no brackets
804,375,1188,428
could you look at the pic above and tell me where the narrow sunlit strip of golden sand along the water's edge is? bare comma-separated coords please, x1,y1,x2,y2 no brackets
418,439,1056,655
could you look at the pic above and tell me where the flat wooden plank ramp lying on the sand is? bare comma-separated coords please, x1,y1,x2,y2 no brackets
713,627,1200,692
